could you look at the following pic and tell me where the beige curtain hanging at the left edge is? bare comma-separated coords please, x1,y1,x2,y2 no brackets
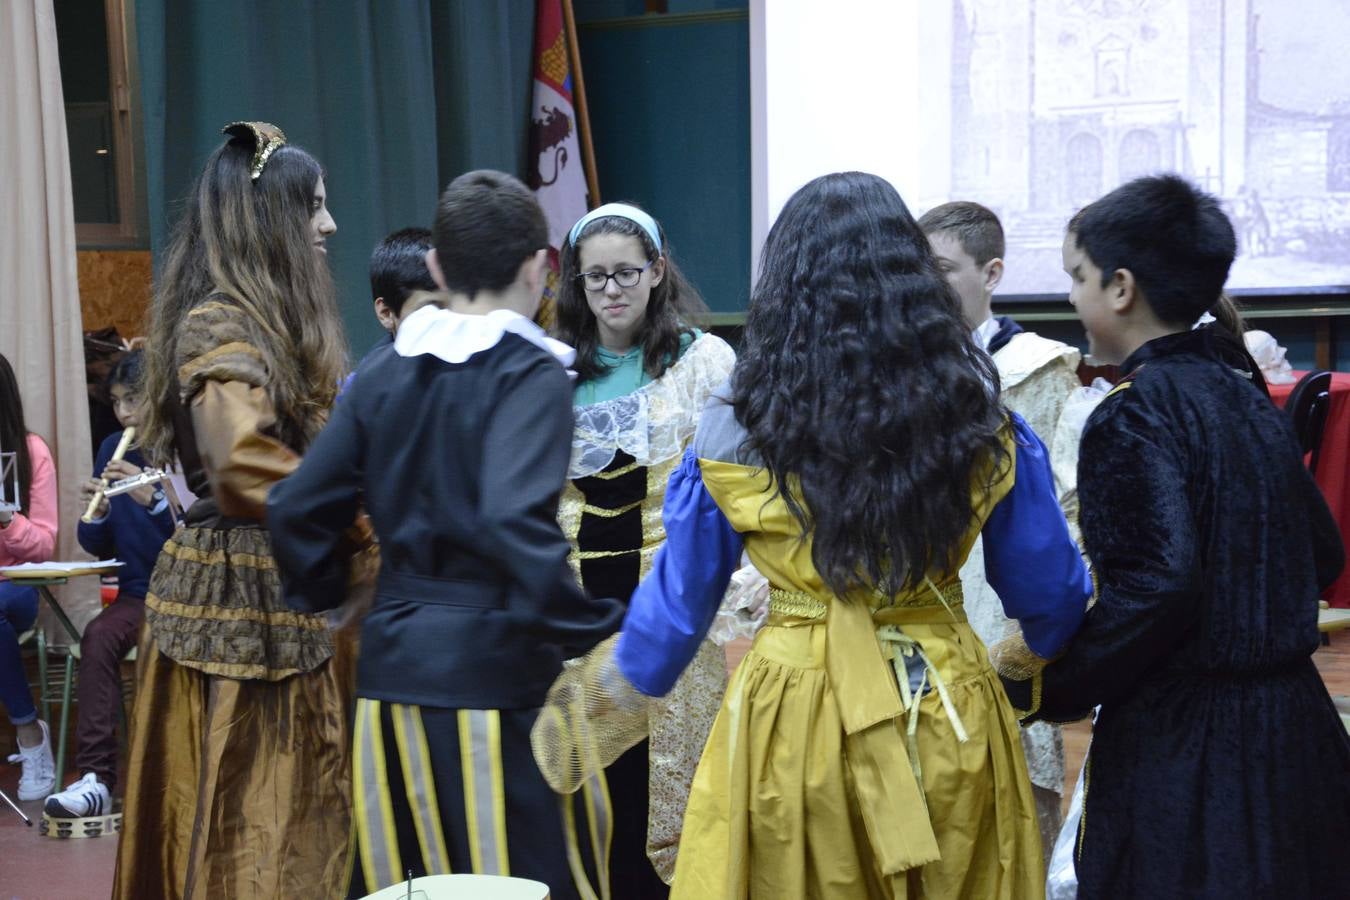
0,0,99,642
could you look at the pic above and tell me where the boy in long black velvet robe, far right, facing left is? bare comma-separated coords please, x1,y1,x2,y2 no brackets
1004,175,1350,899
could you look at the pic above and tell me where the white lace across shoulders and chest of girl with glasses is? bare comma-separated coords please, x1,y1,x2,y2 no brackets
569,334,736,478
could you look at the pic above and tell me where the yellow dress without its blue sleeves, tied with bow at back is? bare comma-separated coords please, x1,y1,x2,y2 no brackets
672,423,1045,900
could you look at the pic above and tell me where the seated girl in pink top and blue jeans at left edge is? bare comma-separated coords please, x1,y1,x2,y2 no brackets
0,355,57,800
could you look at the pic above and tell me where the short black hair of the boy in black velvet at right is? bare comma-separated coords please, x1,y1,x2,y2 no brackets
1068,175,1238,325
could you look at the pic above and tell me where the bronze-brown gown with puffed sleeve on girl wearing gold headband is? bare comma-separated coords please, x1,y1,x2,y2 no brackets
113,300,354,900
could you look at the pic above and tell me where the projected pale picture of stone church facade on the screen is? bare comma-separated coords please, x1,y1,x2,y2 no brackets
918,0,1350,293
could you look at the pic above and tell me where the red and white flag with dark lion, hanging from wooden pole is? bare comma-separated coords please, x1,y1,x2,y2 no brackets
527,0,590,322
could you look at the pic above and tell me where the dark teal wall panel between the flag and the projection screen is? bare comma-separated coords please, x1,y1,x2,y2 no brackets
576,0,756,322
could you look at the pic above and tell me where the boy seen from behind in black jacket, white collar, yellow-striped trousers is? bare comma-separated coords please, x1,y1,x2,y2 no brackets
267,171,621,897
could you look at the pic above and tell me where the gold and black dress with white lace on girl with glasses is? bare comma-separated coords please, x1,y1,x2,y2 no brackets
558,333,736,897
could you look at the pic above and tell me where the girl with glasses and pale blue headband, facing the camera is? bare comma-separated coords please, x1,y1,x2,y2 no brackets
556,204,736,900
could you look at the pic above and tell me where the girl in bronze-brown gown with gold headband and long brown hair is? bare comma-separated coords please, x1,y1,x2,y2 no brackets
113,123,350,897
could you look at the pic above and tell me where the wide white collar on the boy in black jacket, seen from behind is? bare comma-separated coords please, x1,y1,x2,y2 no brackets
394,306,576,378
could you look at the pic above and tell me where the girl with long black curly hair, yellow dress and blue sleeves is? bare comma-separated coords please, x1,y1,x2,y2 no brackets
539,173,1091,899
